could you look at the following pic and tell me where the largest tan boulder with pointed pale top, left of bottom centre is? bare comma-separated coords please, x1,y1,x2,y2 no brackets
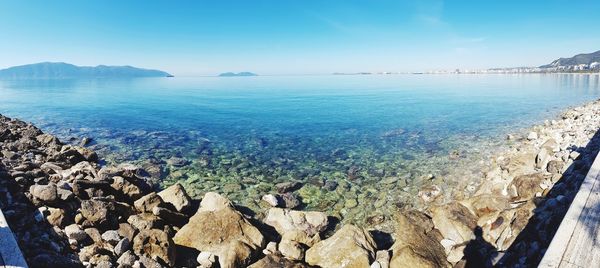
174,192,266,268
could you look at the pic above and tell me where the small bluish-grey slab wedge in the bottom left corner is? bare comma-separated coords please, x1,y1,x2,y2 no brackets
0,210,28,268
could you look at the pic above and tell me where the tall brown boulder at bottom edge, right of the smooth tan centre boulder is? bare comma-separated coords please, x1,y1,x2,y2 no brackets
390,211,450,267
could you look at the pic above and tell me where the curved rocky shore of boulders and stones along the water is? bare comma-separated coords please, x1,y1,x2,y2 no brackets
0,101,600,268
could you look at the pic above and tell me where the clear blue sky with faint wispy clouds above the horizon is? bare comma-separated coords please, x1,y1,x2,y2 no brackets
0,0,600,76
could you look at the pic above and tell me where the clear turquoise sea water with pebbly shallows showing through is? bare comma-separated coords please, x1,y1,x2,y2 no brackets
0,74,600,226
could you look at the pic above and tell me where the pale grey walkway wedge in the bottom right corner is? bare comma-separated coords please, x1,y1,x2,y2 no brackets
538,150,600,268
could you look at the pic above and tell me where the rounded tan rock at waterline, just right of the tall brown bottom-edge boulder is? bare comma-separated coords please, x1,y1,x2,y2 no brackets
431,201,477,243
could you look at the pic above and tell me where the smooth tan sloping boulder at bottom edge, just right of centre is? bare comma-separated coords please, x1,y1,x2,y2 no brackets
306,224,376,267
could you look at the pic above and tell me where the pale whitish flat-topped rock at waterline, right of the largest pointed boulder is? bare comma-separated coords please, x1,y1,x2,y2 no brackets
263,208,329,236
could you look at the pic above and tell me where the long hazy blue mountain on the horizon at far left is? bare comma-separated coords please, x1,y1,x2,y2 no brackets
0,62,172,79
